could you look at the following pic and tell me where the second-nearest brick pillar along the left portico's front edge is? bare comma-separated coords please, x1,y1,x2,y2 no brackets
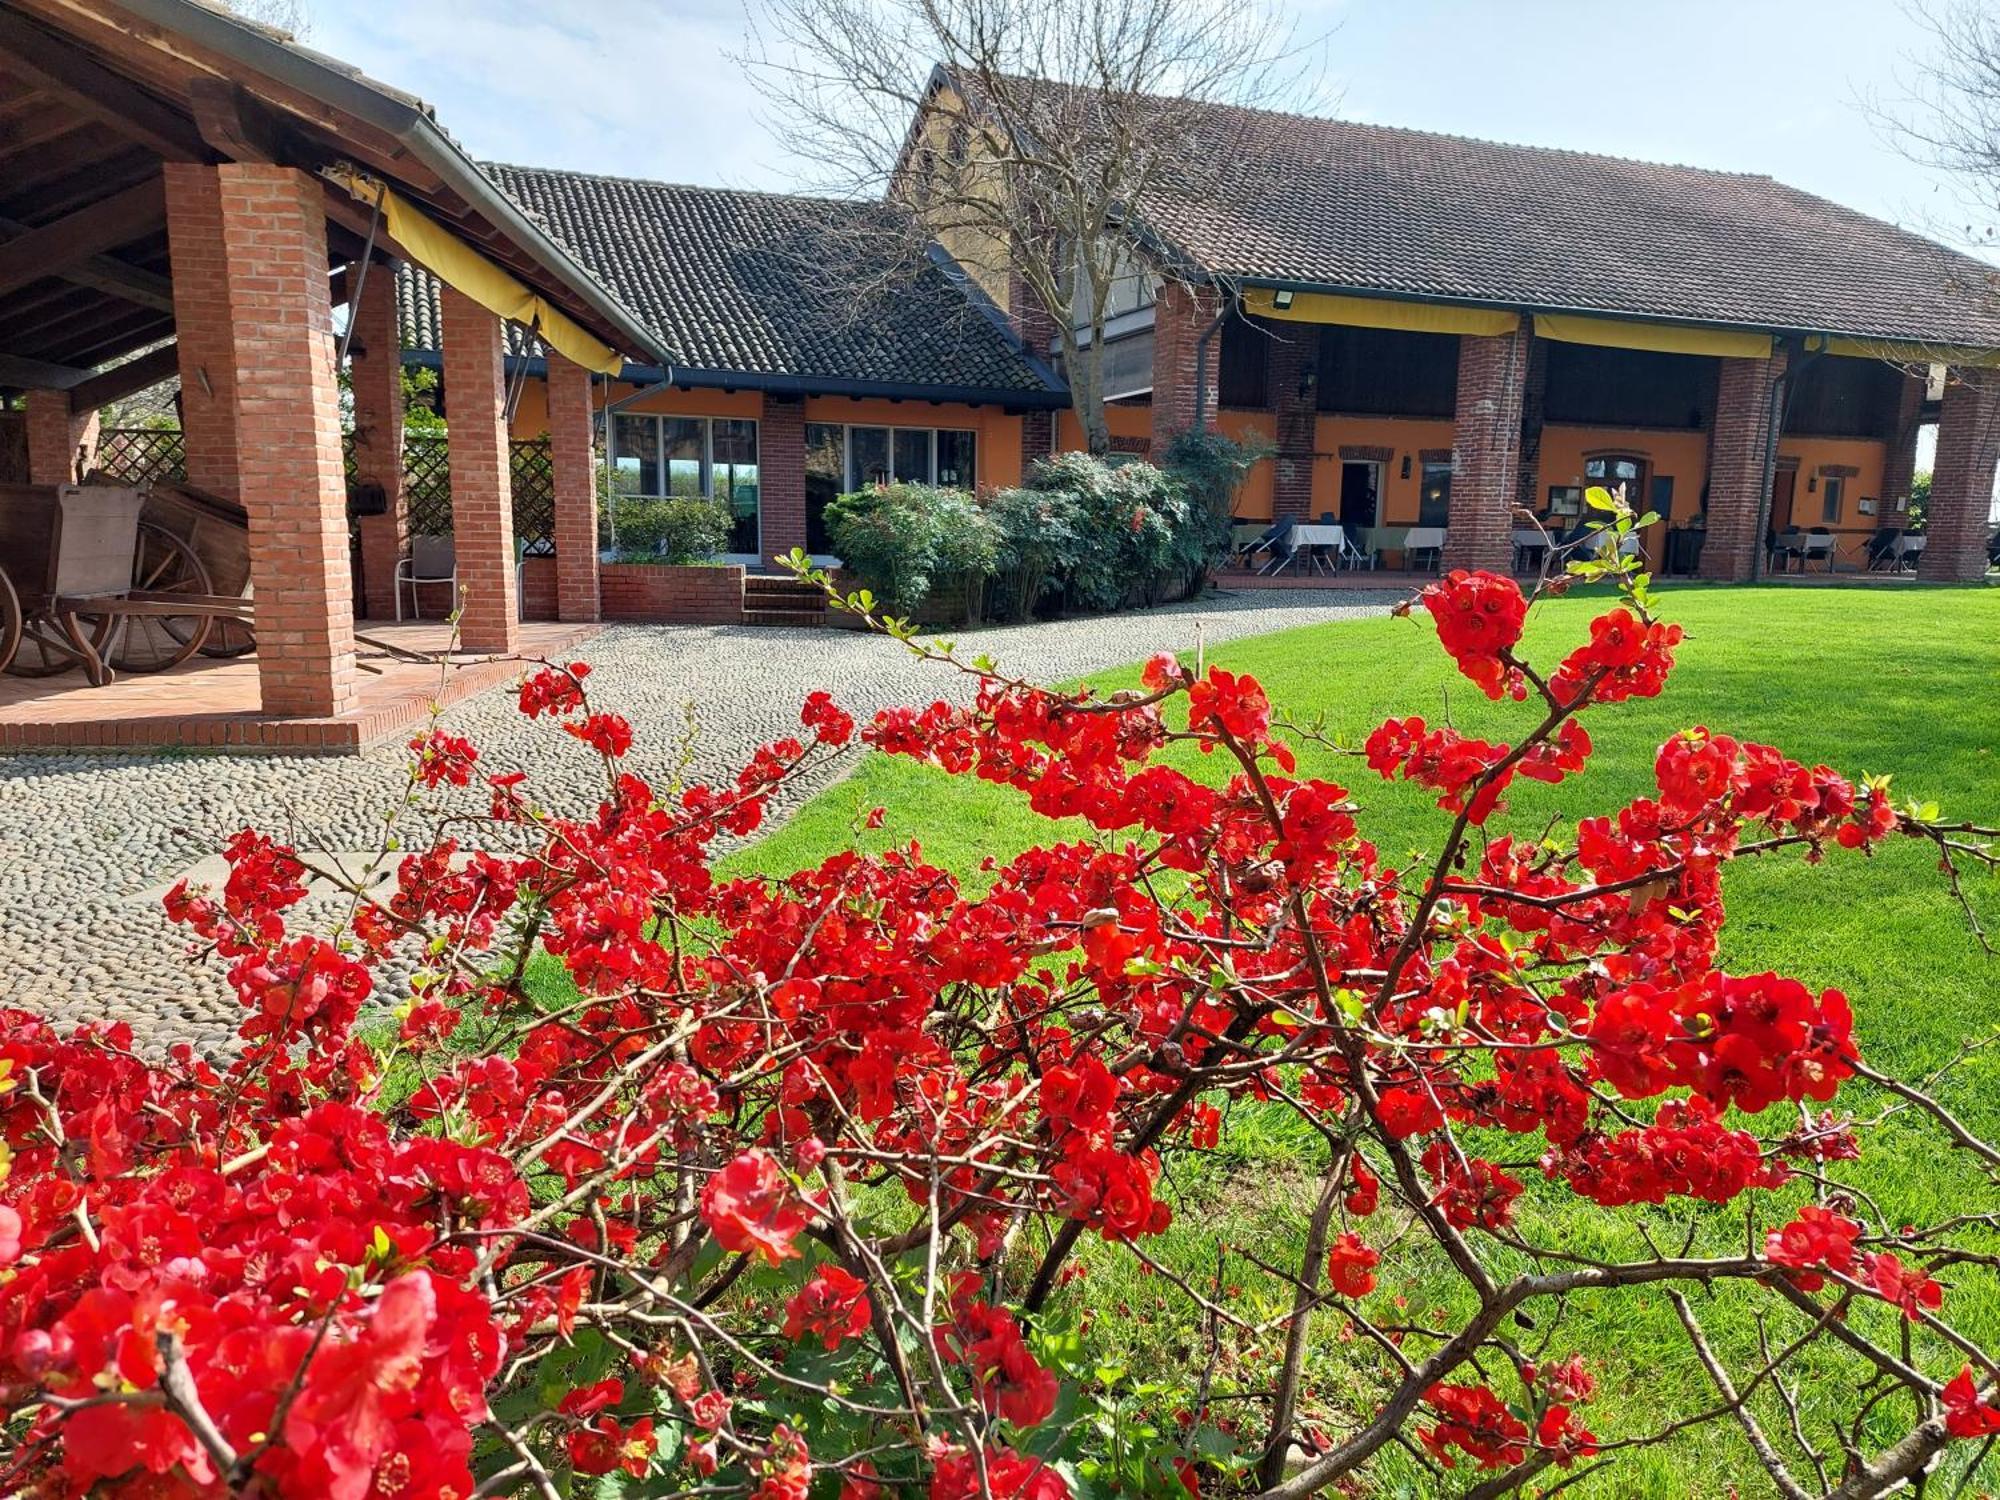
438,286,520,652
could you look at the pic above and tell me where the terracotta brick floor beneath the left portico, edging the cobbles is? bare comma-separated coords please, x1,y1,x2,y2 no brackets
0,620,600,754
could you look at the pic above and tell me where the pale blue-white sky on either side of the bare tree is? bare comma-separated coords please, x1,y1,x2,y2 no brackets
306,0,1962,228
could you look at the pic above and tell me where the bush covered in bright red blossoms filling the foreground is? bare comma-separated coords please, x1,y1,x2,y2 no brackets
0,556,2000,1500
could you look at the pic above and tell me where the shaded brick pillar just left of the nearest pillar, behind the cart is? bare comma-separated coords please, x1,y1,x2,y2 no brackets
164,162,236,500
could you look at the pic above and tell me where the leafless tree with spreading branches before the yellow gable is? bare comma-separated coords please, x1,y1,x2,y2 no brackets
744,0,1314,454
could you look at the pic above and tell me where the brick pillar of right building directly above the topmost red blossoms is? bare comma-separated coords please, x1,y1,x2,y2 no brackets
1444,330,1528,572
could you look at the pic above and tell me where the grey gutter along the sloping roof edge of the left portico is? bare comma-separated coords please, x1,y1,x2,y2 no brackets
116,0,676,380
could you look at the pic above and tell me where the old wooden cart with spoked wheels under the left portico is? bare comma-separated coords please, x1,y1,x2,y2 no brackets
0,484,250,686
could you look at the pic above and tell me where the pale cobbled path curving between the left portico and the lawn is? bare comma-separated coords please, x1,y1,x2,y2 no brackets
0,590,1394,1048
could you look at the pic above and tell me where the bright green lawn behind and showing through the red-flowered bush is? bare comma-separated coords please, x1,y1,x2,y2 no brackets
730,586,2000,1496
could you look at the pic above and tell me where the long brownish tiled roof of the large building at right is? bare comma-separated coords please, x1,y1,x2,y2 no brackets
992,86,2000,346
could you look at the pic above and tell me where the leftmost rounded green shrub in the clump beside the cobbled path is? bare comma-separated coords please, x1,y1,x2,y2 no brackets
826,484,998,614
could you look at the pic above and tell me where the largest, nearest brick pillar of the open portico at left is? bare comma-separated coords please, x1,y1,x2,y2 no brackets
217,162,360,716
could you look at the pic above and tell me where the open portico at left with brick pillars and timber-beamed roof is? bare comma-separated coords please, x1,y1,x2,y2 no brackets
0,0,666,744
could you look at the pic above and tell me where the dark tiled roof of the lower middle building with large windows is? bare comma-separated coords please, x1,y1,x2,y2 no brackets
402,164,1060,400
